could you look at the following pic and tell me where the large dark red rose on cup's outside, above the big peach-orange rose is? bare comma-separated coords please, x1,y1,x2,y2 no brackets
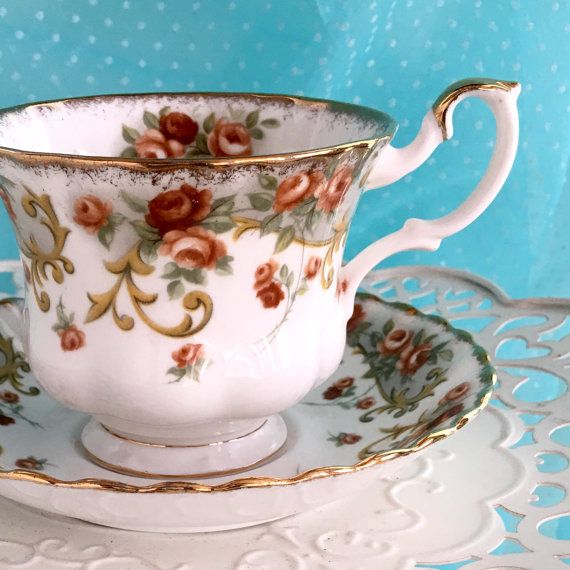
145,184,212,237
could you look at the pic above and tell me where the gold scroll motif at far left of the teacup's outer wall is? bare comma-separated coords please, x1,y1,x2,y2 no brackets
20,186,75,313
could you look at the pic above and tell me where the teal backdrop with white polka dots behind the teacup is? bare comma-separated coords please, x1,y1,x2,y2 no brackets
0,0,570,296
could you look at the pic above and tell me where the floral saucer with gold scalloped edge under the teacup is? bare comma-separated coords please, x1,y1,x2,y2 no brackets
0,295,495,532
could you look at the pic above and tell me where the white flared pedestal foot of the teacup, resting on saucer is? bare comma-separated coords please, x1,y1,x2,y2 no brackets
81,415,287,479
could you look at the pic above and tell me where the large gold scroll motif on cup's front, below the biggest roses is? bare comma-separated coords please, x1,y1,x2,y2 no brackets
85,241,210,337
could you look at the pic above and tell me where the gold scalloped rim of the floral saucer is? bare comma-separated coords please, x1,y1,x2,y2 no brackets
0,293,497,493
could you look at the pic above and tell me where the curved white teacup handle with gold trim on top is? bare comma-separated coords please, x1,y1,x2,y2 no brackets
339,79,521,310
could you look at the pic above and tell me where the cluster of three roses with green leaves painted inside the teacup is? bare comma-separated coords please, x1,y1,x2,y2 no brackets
121,107,281,159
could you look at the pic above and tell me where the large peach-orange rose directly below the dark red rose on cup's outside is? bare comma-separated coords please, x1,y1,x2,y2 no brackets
158,226,227,269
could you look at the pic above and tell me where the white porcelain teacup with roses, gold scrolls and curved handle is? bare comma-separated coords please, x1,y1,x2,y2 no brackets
0,79,520,477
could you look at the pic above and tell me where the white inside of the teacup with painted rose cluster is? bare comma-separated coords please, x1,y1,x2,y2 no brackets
0,93,396,159
